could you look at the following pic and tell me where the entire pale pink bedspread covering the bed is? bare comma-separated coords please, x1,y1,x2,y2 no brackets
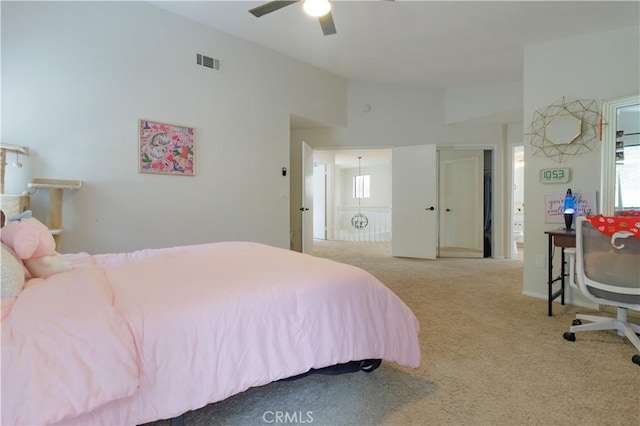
2,242,420,425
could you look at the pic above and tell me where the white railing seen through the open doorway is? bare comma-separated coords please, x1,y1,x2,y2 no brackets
328,207,391,241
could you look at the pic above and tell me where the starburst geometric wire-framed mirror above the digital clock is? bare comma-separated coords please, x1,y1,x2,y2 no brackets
526,97,602,163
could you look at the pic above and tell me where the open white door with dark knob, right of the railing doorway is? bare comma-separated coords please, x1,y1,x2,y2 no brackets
391,145,438,259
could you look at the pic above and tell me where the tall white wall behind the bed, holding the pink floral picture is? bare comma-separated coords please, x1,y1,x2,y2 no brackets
2,2,347,253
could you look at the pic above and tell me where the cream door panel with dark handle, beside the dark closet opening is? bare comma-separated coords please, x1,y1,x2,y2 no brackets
439,150,484,257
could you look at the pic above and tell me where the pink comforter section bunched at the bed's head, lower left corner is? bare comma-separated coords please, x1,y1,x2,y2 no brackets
1,254,139,425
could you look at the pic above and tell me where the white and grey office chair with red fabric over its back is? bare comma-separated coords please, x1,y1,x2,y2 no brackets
563,216,640,366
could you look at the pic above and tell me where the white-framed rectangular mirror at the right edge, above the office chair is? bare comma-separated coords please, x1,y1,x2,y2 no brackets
600,95,640,216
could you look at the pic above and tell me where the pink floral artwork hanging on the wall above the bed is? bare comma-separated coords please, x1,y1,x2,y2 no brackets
138,120,196,176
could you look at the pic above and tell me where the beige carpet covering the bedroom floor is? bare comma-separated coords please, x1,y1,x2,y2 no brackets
149,241,640,426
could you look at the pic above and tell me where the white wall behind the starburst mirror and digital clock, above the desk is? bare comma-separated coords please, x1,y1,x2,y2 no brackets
524,27,640,303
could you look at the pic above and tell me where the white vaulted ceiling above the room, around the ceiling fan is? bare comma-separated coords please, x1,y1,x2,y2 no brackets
152,0,640,89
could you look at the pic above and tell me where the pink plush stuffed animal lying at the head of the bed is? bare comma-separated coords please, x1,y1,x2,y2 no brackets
0,210,71,278
